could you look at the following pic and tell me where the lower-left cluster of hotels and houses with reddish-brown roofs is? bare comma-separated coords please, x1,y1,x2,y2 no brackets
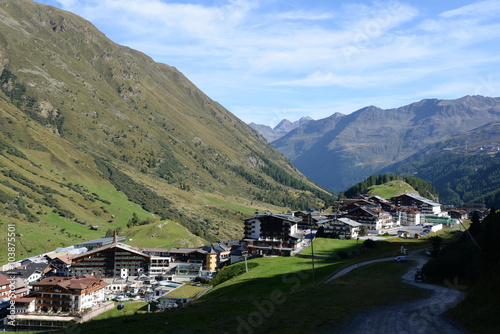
0,234,241,330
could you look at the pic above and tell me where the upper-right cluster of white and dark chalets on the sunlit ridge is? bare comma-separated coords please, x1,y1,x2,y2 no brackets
242,193,487,256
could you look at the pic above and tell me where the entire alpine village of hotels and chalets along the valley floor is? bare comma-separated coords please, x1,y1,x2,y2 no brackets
0,194,486,330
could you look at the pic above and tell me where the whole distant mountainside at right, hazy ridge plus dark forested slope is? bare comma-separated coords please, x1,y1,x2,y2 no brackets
262,96,500,206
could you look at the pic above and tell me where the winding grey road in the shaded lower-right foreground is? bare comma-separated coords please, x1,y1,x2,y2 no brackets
325,254,468,334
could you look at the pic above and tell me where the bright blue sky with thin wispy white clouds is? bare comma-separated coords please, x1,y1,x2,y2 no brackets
37,0,500,127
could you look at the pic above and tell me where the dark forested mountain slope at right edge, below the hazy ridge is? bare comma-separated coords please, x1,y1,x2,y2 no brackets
384,122,500,207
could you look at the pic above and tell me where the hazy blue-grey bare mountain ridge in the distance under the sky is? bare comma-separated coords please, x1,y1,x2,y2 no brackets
273,96,500,191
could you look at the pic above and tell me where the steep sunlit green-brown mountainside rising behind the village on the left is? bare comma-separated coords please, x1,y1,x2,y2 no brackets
0,0,330,258
